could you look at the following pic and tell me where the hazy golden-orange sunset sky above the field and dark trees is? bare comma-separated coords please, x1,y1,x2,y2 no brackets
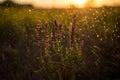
0,0,120,8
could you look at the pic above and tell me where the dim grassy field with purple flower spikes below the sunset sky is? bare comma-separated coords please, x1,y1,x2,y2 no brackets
0,7,120,80
